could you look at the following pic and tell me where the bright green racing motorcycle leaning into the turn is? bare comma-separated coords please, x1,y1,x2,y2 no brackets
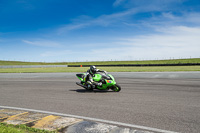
76,72,121,92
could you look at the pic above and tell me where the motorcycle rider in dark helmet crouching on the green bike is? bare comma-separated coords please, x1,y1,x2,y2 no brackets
84,66,107,90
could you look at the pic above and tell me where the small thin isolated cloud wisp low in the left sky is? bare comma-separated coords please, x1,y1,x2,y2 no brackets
22,40,62,47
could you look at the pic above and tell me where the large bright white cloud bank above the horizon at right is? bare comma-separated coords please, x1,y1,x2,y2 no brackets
87,26,200,60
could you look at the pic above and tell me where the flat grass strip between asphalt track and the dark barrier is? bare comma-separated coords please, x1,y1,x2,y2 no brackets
0,66,200,73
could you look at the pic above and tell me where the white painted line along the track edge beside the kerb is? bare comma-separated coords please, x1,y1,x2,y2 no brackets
0,106,177,133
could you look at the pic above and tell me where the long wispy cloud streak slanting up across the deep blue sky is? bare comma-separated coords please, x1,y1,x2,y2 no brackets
58,5,163,34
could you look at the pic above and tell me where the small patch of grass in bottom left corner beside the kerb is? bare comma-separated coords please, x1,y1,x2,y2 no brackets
0,123,57,133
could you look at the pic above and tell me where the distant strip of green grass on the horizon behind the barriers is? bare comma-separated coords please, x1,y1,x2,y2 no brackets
0,58,200,65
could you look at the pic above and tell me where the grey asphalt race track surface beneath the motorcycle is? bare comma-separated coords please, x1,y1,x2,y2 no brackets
0,72,200,133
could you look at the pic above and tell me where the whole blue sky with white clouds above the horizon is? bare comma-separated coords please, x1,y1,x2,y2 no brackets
0,0,200,62
